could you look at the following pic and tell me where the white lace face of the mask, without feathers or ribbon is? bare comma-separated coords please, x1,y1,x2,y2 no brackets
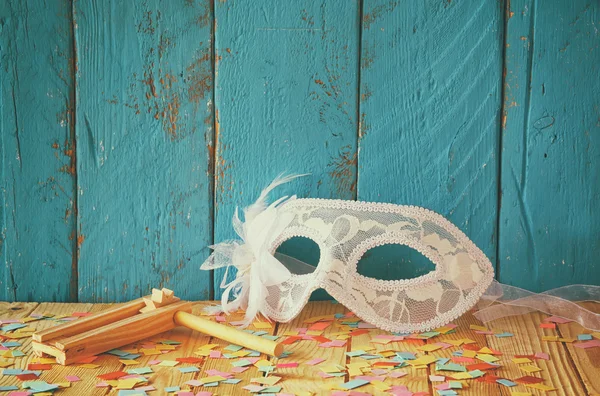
265,199,493,332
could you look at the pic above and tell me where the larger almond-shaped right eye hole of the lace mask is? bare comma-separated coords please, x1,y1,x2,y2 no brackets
357,243,435,280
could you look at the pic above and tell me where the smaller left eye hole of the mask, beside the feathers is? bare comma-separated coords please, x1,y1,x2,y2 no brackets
275,237,321,275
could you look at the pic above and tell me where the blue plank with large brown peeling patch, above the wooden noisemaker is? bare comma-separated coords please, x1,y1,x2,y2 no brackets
75,0,213,301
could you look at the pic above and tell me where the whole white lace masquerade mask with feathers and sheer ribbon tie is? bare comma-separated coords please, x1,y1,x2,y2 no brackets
201,176,600,333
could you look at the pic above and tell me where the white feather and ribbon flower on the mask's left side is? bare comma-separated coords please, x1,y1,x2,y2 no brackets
200,175,304,326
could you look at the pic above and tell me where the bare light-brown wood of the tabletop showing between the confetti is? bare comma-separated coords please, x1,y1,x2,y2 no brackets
0,301,600,396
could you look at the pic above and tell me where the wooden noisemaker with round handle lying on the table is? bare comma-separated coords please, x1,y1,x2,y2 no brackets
31,289,283,365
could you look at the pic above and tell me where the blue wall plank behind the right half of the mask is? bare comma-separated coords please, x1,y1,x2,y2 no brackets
358,0,503,278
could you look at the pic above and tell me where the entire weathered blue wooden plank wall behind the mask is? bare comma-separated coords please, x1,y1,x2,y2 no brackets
0,0,600,302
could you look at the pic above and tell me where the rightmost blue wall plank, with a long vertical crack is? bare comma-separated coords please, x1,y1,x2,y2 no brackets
498,0,600,291
